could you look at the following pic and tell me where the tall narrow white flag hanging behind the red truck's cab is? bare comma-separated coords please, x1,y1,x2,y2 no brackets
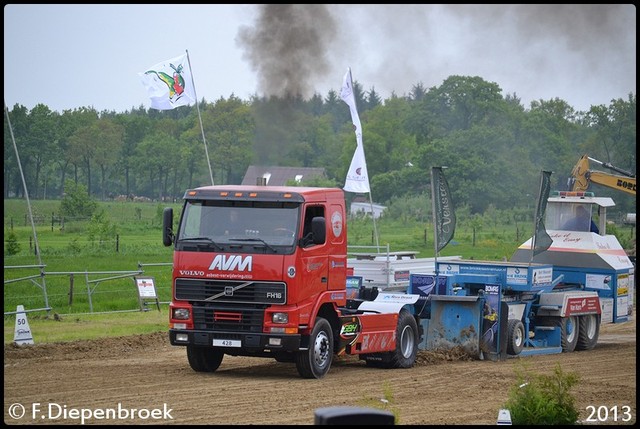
340,68,371,193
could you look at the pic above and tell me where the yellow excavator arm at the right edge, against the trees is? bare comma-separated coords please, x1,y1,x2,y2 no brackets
569,155,636,195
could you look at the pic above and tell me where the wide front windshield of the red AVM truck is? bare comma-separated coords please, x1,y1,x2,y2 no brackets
177,200,300,253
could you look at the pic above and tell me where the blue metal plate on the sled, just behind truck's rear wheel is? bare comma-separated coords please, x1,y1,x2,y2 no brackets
426,295,484,359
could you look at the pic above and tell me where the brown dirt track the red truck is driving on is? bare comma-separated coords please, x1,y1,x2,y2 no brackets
4,315,636,425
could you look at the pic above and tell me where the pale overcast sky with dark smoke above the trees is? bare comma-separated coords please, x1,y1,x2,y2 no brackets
4,4,636,112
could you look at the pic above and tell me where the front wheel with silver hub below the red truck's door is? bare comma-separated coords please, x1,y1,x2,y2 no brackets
296,317,333,378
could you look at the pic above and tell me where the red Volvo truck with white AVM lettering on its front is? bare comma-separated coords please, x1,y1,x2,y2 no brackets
163,184,421,378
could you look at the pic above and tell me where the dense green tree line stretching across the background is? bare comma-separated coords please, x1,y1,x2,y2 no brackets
4,76,636,213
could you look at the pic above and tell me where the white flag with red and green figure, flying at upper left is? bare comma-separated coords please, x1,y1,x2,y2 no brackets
138,54,196,110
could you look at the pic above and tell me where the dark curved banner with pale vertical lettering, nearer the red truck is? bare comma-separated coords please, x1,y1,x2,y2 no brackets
431,167,456,253
